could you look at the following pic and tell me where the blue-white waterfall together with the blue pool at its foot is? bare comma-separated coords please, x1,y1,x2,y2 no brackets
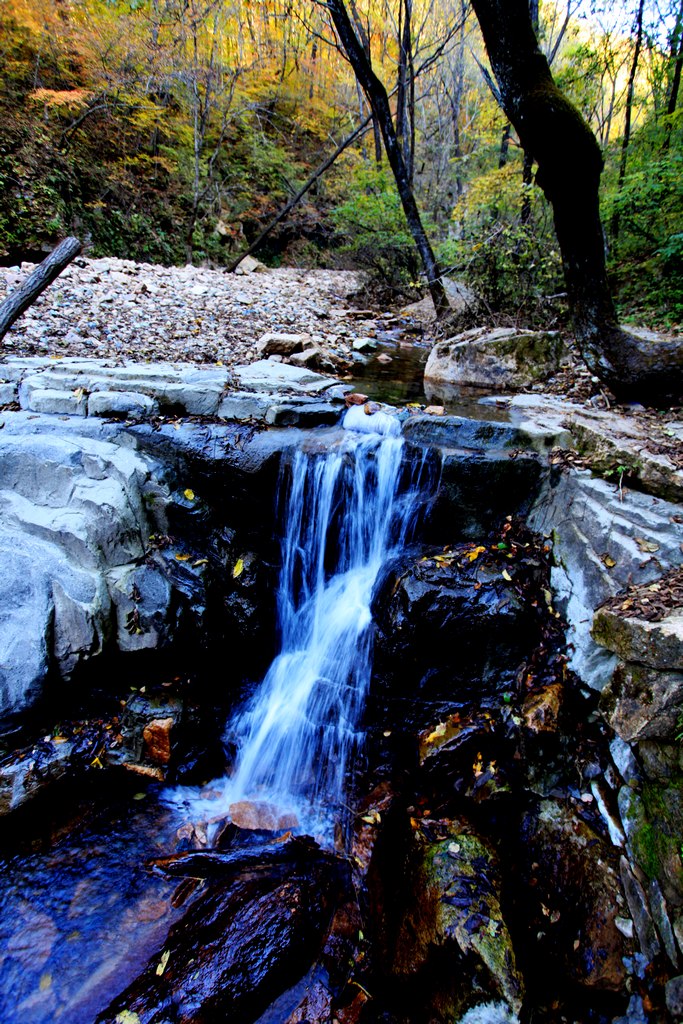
0,410,433,1024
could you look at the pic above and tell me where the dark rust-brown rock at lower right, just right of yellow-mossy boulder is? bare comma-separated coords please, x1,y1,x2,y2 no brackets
520,800,632,992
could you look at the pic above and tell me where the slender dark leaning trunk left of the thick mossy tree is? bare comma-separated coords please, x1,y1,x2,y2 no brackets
325,0,451,319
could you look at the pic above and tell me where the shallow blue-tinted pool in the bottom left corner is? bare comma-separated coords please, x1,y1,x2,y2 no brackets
0,792,187,1024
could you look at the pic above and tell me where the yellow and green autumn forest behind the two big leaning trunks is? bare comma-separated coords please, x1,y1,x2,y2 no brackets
0,0,683,328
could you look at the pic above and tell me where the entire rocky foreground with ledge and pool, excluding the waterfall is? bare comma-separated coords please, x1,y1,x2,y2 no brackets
0,359,683,1024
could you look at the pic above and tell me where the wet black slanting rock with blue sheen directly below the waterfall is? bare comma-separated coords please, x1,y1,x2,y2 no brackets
98,860,338,1024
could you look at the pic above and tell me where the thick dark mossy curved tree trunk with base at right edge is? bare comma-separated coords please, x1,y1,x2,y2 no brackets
472,0,683,403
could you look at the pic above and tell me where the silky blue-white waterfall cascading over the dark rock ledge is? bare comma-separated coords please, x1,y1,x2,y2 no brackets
178,410,427,839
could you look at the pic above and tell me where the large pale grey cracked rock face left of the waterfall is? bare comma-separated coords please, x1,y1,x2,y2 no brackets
0,422,165,716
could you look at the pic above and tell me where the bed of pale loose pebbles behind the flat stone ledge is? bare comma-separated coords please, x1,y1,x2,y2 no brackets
0,258,368,367
